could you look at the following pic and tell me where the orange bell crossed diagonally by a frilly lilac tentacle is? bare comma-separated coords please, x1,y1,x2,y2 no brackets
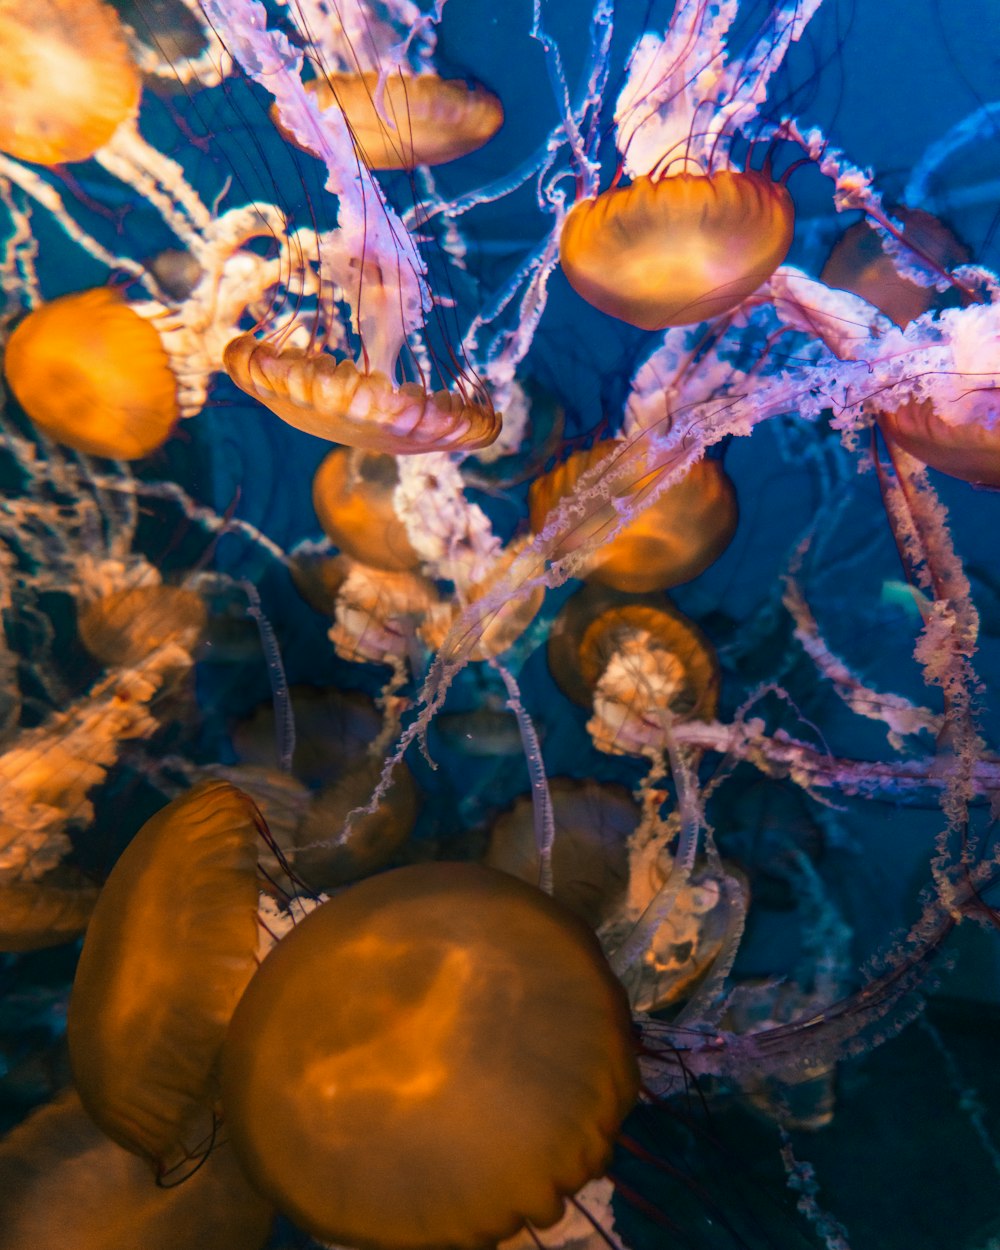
528,440,739,595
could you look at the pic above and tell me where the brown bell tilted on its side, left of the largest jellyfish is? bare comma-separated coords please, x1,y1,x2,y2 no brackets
68,781,259,1170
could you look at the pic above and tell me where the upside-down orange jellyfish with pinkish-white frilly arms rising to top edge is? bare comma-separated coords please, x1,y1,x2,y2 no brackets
559,0,816,330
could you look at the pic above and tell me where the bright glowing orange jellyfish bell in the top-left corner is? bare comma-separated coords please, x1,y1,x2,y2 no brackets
0,0,141,165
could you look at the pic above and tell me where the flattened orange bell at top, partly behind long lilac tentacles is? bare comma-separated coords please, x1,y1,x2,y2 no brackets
285,70,504,170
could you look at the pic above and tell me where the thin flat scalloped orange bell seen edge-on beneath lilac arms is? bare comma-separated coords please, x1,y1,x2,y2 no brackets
223,334,500,456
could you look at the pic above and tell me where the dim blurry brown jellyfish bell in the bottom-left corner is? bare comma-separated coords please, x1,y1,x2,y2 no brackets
0,1090,273,1250
